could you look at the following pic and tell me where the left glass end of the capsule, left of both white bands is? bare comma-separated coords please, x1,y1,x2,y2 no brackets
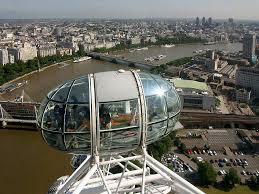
37,76,91,153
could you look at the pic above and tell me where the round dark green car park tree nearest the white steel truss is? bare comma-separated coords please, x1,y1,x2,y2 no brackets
198,161,217,186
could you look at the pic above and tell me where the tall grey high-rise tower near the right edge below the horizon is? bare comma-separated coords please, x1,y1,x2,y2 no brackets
243,33,256,61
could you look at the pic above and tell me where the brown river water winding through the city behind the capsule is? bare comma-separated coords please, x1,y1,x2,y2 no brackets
0,43,242,194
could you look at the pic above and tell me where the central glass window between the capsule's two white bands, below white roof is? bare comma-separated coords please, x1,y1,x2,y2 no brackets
99,99,140,151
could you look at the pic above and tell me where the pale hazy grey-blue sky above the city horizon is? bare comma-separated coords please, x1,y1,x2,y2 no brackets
0,0,259,20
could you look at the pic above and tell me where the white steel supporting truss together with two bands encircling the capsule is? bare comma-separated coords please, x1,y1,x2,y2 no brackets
51,71,204,194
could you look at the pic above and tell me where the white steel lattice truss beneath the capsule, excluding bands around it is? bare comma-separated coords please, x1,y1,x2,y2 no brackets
57,148,204,194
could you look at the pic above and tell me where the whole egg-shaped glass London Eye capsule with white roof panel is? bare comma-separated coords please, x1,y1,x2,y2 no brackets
37,71,181,155
